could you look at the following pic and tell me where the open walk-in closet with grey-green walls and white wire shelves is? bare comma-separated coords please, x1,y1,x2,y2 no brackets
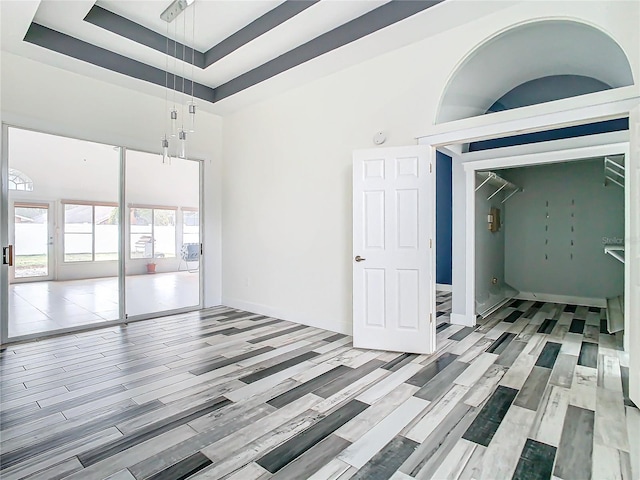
475,155,625,333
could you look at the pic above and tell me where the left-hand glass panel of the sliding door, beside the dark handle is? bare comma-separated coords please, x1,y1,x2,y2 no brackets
7,127,121,339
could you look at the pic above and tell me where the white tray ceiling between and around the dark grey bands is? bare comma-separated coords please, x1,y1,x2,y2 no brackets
0,0,514,114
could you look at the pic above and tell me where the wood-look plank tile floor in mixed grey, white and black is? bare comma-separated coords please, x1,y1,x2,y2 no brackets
0,293,640,480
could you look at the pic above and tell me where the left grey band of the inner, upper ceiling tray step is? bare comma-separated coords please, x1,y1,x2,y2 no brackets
84,5,205,68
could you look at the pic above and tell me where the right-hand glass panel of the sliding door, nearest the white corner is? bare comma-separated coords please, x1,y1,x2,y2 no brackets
125,150,201,316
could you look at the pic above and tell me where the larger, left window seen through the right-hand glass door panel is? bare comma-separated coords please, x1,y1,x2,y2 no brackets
129,206,177,259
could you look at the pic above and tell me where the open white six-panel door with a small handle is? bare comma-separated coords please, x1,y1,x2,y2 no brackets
352,145,435,353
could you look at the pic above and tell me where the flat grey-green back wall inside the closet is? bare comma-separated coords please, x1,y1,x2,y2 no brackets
500,159,624,298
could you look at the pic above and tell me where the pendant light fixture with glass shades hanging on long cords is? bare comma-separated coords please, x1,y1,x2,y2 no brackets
160,0,196,165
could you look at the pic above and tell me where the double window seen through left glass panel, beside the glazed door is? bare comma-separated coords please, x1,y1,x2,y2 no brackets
63,202,118,262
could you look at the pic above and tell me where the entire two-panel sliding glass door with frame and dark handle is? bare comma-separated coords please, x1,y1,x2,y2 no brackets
0,125,202,343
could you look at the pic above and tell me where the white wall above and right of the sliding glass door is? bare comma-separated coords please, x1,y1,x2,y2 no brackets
1,52,222,306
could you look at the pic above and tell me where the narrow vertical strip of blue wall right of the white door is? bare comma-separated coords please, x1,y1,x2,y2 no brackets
436,152,453,285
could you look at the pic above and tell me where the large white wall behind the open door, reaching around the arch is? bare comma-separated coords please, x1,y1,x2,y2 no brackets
223,2,640,332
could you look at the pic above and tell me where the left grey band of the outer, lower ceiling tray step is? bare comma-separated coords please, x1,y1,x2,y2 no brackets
24,23,215,103
